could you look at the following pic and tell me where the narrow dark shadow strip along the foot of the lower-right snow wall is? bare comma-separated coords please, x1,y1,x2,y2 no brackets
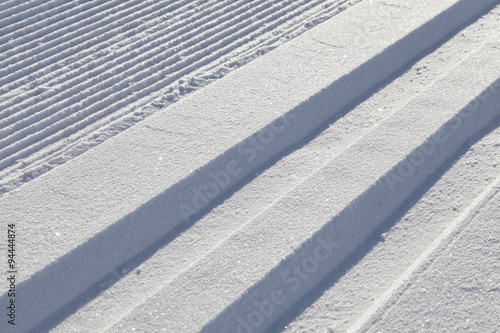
266,117,500,333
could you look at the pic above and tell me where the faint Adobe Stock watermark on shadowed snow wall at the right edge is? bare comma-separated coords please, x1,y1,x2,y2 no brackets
384,81,500,193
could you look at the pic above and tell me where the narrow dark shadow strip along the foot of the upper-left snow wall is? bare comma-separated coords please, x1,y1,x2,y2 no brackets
31,4,497,332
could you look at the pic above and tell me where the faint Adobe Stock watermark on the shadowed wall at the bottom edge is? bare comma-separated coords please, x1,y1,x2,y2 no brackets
236,236,340,333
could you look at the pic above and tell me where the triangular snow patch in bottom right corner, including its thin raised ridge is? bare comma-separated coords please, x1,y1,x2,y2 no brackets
351,177,500,332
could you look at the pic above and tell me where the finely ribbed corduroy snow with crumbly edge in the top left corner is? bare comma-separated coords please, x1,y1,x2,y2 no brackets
0,0,359,193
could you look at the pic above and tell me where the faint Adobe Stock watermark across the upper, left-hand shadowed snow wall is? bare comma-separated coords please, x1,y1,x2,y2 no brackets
178,113,296,223
